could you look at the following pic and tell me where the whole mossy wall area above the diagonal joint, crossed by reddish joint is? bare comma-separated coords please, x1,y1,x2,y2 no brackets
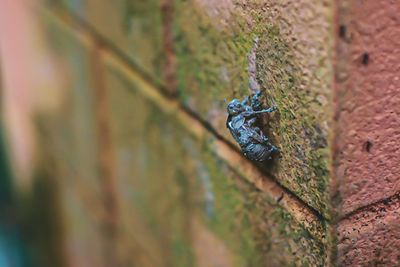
47,0,333,220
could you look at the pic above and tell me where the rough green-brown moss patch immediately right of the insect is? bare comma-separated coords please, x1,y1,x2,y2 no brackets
257,27,329,216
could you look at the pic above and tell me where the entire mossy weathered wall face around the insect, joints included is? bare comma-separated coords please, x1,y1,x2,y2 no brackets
0,1,332,266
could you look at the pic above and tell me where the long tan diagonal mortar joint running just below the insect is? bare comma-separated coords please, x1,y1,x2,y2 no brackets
40,4,328,240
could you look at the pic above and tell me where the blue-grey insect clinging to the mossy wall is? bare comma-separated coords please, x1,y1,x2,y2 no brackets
226,91,278,161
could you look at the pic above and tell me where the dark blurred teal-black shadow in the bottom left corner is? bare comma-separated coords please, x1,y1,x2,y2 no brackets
0,125,65,267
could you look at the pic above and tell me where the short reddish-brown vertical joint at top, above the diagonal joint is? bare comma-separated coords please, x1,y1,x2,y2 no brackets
161,0,177,96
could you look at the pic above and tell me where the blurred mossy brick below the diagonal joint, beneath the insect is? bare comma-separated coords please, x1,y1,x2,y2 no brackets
104,54,328,266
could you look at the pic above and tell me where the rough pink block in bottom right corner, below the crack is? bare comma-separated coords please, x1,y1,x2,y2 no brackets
337,194,400,266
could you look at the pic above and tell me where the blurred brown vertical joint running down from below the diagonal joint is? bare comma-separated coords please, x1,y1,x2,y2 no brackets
90,38,119,266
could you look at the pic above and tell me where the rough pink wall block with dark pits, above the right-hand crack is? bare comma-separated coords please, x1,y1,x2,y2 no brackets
336,1,400,214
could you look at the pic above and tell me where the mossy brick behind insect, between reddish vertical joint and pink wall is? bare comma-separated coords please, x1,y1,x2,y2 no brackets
174,0,333,217
